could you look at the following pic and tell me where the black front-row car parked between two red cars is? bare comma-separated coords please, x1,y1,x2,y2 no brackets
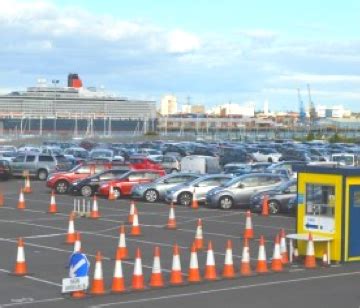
69,168,129,197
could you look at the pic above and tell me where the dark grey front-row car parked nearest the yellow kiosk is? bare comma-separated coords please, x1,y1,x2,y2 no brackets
250,179,297,214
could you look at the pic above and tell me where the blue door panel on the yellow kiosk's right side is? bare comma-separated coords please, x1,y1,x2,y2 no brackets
349,185,360,258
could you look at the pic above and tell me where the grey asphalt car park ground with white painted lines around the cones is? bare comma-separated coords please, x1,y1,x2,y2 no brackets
0,180,360,308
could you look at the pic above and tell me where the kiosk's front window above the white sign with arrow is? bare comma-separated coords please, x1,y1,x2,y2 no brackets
306,184,335,217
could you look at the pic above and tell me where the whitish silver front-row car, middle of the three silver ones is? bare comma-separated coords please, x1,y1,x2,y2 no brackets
165,174,232,206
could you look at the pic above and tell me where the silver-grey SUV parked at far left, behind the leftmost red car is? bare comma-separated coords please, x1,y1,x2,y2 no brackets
10,153,71,181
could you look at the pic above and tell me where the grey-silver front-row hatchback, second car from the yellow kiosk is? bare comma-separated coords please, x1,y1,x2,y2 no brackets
206,173,286,210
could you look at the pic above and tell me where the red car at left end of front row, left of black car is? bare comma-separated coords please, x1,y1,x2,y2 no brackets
46,164,111,194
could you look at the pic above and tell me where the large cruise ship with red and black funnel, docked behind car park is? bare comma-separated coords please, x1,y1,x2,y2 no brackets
0,74,156,134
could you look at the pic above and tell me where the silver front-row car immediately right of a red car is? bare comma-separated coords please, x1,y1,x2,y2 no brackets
132,173,200,202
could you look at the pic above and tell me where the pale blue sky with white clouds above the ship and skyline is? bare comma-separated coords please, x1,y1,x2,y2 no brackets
0,0,360,111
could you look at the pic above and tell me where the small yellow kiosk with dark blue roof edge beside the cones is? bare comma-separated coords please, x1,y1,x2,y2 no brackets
293,166,360,262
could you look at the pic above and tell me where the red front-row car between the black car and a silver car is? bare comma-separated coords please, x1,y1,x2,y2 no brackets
98,170,165,199
